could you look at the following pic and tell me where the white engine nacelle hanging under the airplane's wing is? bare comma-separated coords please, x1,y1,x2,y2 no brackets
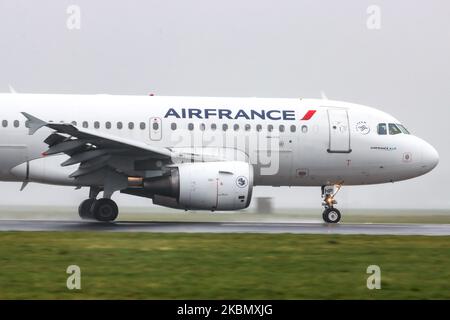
148,161,253,211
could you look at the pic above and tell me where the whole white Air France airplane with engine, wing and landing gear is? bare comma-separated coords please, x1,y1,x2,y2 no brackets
0,93,439,223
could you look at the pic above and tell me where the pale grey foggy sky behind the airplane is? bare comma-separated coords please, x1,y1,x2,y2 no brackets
0,0,450,209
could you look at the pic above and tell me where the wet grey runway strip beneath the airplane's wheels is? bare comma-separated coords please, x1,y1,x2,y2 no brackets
0,220,450,236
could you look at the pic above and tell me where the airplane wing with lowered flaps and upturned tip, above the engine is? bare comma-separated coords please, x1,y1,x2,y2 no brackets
22,112,244,195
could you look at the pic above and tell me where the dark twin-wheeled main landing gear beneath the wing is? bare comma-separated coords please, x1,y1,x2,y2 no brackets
78,188,119,222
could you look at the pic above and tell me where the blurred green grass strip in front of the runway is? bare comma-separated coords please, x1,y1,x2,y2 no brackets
0,232,450,299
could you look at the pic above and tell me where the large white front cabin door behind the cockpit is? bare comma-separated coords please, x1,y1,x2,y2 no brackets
327,109,352,153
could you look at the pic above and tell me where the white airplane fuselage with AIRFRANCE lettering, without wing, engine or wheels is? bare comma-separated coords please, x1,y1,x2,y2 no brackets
0,94,438,186
